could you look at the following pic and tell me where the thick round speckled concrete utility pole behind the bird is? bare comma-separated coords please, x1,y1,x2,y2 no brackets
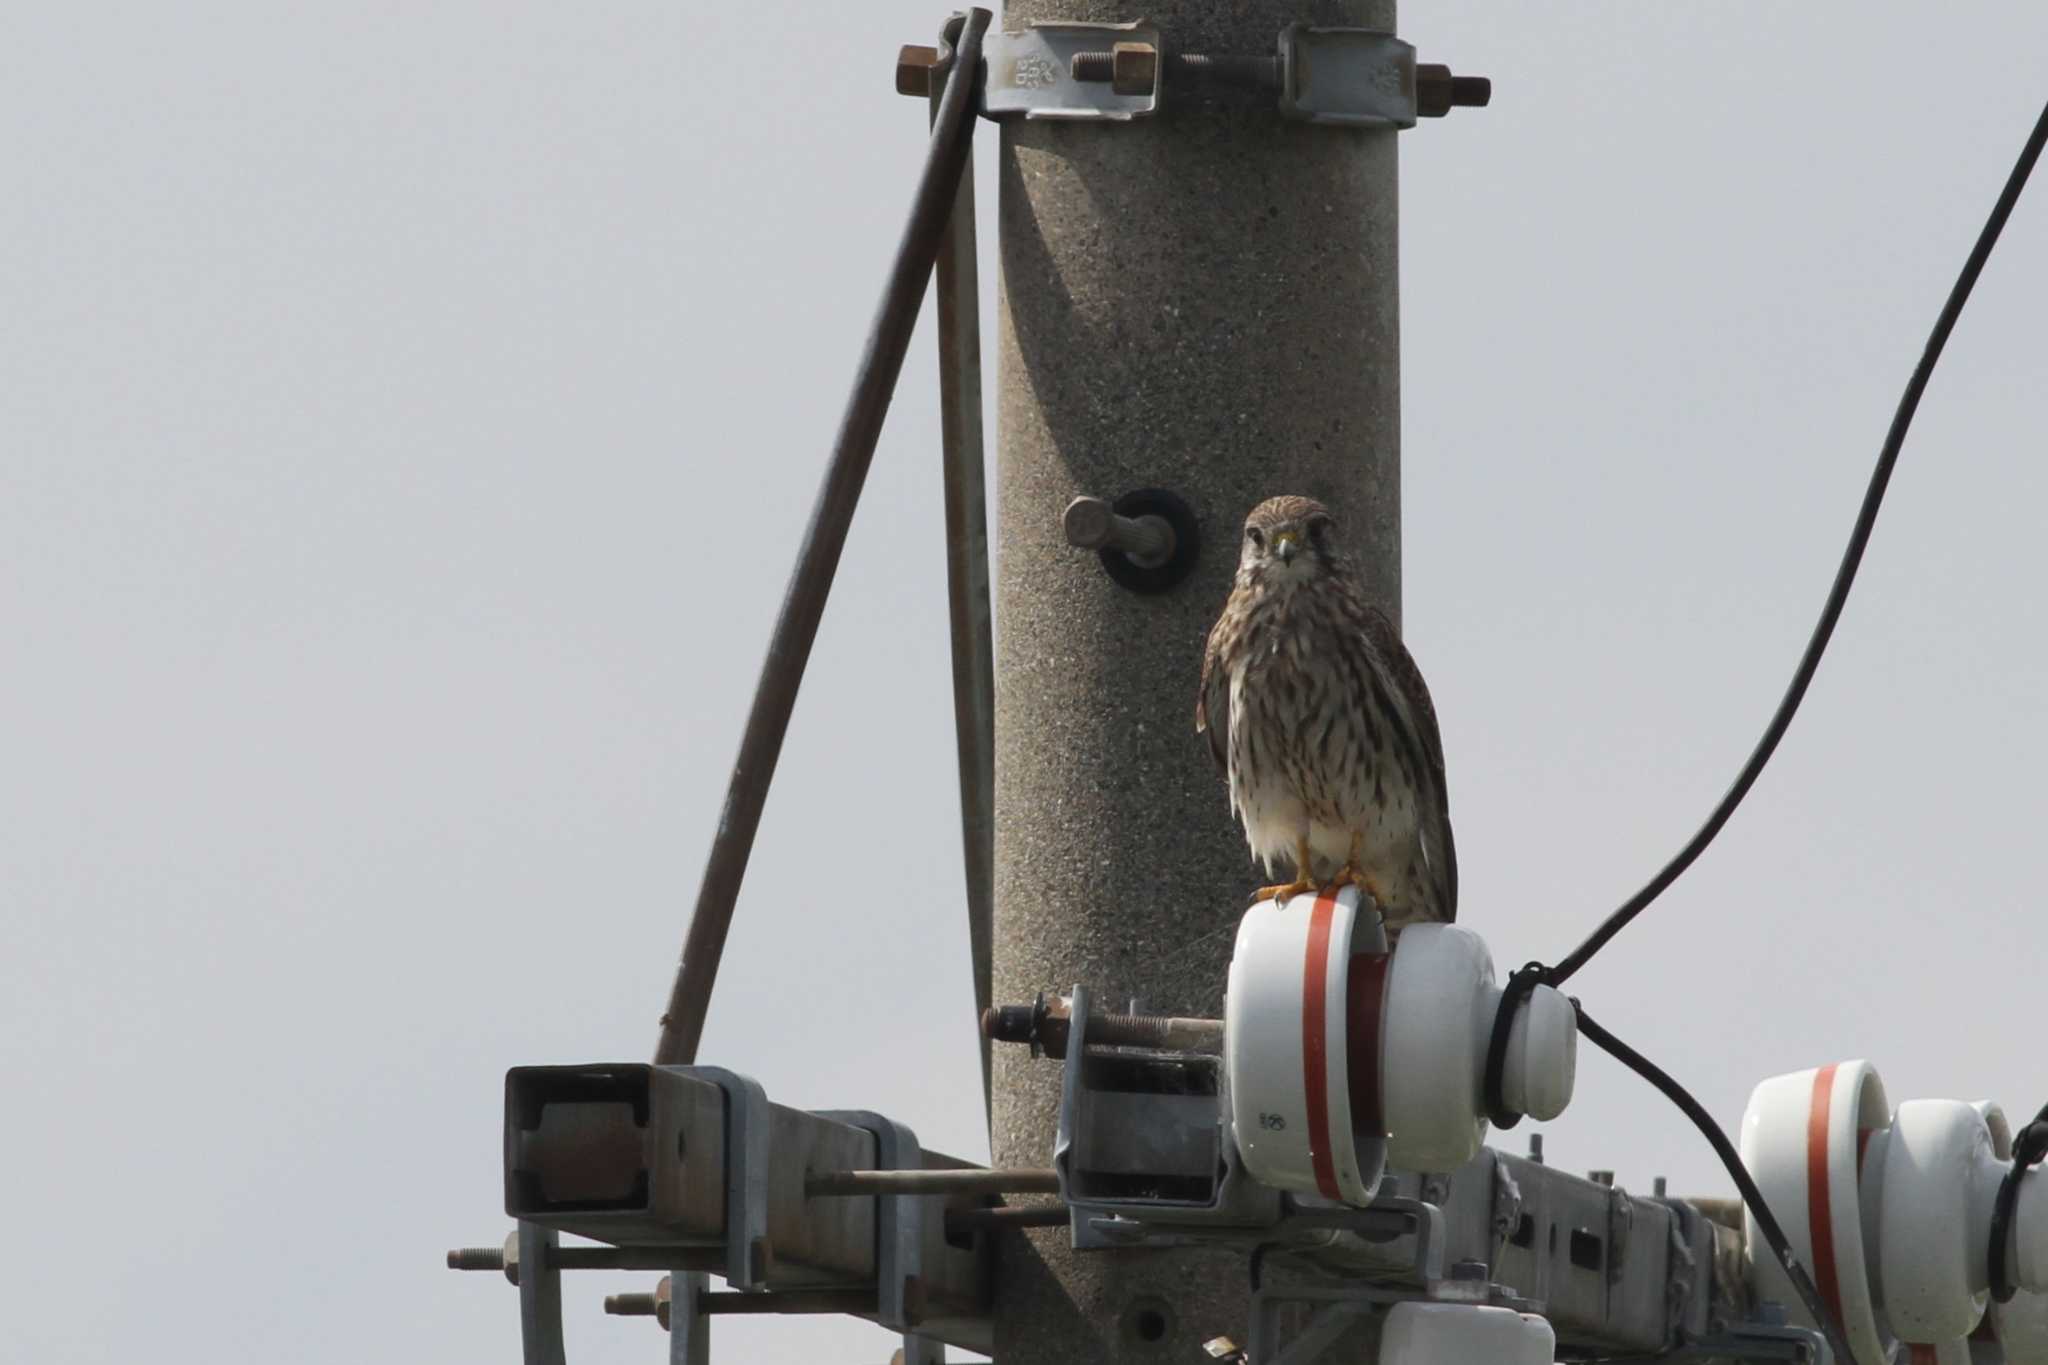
993,0,1401,1365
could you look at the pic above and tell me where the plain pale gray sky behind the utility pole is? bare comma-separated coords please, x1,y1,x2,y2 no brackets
0,0,2048,1365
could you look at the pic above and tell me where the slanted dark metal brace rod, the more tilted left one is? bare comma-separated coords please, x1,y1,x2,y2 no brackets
653,10,991,1066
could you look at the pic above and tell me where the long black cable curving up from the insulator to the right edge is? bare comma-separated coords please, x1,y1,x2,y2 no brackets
1544,93,2048,986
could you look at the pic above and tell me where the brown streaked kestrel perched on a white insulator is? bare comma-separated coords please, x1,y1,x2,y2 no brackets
1194,497,1458,929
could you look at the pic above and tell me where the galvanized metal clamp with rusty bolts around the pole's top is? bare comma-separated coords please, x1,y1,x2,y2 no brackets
897,20,1493,129
